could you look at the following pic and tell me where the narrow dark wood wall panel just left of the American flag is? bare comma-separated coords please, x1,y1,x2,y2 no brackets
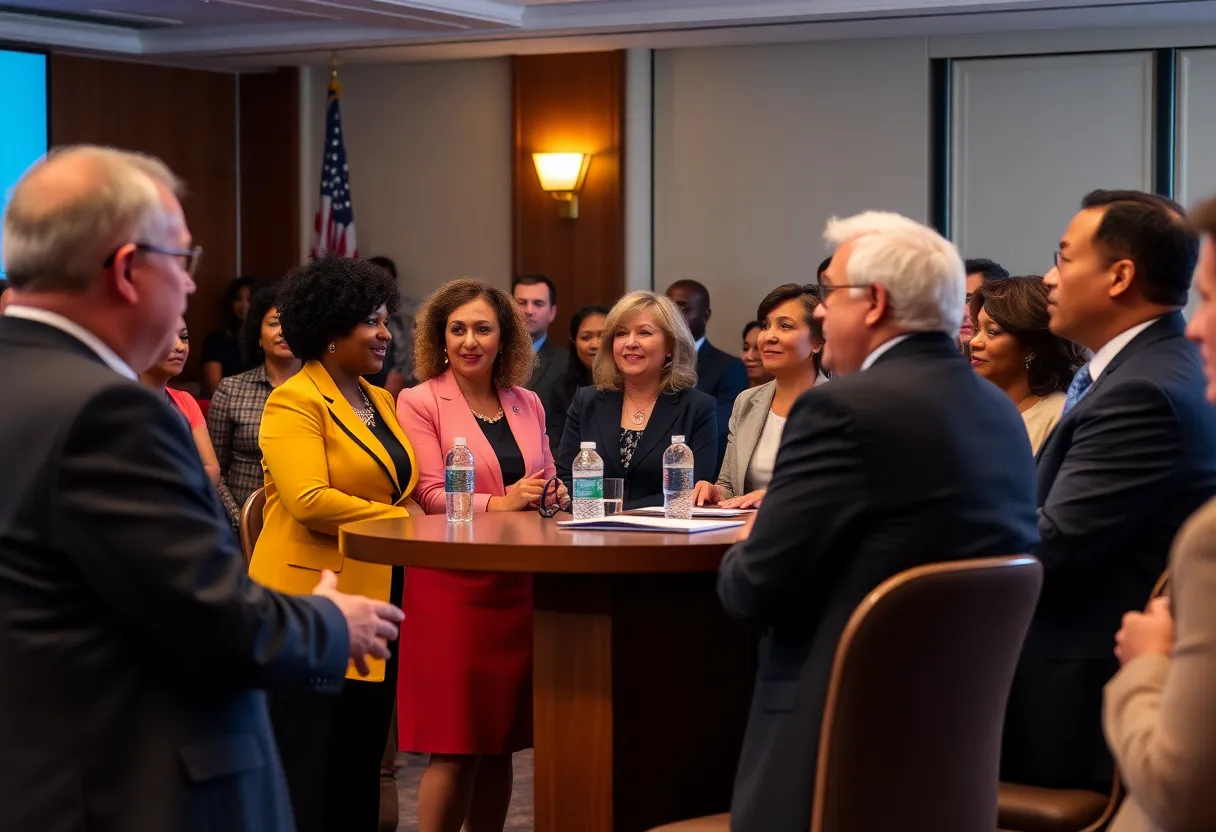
237,67,300,277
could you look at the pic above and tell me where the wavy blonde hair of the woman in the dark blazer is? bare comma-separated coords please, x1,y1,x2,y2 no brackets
591,292,697,393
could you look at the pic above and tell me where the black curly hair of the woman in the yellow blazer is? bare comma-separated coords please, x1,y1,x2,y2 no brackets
277,257,401,361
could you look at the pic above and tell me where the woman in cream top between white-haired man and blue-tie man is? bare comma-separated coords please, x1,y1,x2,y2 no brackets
970,276,1086,454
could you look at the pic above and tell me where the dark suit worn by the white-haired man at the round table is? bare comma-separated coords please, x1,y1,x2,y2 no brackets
717,333,1036,832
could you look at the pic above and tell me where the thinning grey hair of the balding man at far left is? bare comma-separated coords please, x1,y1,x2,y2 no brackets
4,145,182,292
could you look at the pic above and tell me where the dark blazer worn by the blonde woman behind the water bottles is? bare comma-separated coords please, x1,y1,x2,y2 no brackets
557,387,717,508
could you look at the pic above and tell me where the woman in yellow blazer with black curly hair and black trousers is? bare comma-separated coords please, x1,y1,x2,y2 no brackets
249,258,418,832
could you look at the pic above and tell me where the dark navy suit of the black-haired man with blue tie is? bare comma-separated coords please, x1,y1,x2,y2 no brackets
1001,313,1216,789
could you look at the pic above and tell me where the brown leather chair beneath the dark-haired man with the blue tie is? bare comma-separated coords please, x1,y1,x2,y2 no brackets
997,569,1170,832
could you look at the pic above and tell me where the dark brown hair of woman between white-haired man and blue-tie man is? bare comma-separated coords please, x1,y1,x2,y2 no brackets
970,275,1086,395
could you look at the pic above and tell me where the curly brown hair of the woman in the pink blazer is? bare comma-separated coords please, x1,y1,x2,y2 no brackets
413,277,536,389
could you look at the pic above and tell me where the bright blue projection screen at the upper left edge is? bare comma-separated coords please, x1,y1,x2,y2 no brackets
0,49,46,277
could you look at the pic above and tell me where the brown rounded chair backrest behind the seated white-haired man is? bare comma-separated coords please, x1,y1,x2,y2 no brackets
811,556,1043,832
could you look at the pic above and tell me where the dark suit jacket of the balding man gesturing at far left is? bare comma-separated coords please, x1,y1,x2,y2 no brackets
0,317,349,832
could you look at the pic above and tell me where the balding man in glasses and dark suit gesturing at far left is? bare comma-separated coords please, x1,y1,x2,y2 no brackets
0,147,402,832
